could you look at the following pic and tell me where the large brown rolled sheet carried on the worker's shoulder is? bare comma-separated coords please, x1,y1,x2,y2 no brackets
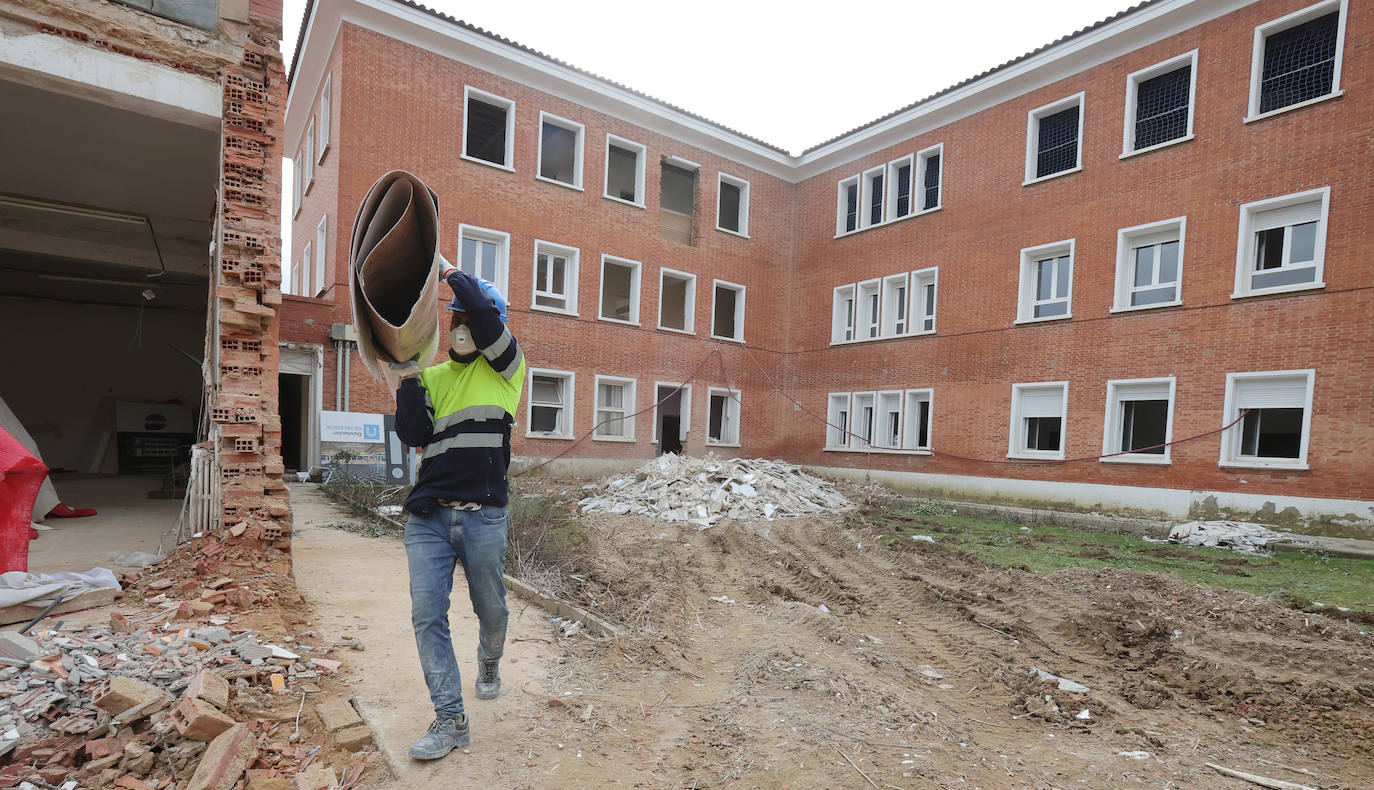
348,170,441,389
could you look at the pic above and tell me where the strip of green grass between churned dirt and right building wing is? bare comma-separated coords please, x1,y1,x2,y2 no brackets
859,501,1374,621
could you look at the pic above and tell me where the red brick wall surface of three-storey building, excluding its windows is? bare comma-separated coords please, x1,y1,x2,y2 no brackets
294,0,1374,499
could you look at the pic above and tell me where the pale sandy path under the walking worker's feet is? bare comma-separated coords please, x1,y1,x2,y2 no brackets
291,485,556,787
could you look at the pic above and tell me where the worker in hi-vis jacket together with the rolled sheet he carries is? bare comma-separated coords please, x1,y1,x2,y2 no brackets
353,173,525,760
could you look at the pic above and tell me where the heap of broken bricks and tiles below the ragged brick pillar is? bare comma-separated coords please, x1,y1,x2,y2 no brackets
0,540,372,790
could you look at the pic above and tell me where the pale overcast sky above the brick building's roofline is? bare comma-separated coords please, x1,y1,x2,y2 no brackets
282,0,1134,258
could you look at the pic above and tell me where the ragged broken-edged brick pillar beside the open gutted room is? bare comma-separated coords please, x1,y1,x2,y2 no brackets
207,3,291,548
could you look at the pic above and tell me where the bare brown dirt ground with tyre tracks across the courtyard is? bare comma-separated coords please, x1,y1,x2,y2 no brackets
292,483,1374,790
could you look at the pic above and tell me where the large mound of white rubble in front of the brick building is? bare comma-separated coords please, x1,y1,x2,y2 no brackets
578,453,853,529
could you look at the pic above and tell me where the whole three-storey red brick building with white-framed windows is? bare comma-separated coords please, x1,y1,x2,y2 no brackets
282,0,1374,526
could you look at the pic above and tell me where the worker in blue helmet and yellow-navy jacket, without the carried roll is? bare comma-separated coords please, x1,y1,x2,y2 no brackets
390,267,525,760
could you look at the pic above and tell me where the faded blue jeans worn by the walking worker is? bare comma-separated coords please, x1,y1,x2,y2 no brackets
405,506,510,719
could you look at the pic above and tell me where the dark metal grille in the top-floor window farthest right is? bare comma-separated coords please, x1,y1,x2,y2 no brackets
1260,11,1340,113
